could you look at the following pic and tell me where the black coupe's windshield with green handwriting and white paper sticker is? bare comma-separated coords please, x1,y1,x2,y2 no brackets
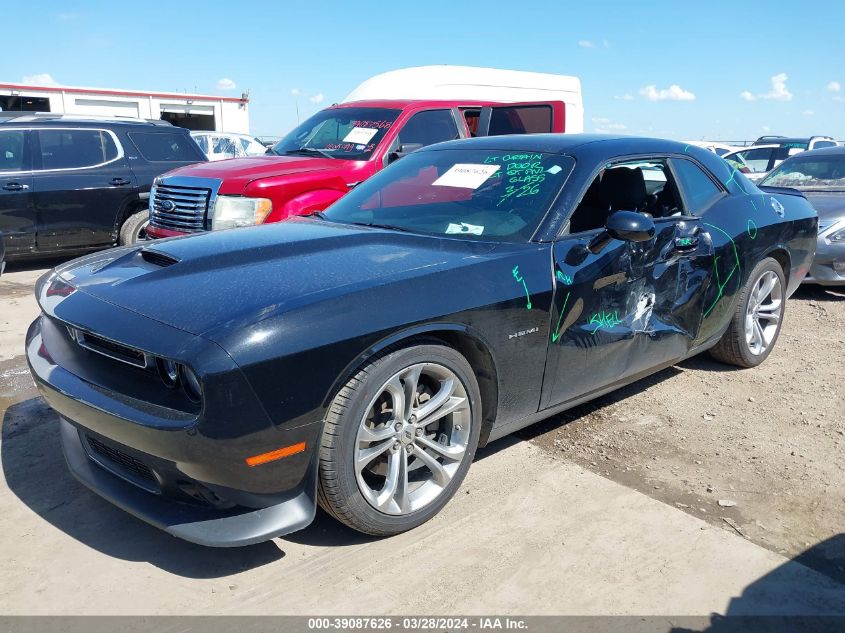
323,149,574,242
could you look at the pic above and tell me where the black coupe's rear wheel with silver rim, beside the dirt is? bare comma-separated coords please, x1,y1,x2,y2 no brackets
710,257,786,367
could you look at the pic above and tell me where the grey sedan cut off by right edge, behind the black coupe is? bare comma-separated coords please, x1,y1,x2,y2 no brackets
760,146,845,286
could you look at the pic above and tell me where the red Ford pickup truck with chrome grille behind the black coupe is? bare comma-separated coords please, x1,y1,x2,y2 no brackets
147,100,566,238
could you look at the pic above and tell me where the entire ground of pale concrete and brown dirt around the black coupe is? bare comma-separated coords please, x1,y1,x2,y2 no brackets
0,264,845,615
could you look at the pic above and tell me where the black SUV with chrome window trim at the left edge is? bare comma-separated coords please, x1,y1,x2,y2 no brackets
0,112,206,260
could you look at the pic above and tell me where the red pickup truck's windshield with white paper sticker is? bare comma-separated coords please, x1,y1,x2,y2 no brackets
269,108,401,160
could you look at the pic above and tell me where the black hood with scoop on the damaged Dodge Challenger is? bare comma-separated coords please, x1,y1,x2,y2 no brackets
56,218,494,335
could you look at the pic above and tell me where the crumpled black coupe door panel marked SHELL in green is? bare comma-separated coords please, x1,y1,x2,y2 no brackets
541,217,713,408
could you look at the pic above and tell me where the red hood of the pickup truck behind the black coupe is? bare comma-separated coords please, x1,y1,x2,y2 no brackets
165,155,350,188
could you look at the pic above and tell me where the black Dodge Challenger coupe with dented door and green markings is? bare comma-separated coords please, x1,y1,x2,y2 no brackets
26,135,817,546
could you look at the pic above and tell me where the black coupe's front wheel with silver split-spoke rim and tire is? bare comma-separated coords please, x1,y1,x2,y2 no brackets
317,343,482,536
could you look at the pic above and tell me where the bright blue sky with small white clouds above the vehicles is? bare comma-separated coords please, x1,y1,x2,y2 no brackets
0,0,845,140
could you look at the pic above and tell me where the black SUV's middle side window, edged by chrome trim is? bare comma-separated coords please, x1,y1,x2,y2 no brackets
38,129,118,169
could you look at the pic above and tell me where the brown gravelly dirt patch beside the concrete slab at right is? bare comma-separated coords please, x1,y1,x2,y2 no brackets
522,287,845,582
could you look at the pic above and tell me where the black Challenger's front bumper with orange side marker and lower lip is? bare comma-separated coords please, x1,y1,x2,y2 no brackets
26,317,322,547
